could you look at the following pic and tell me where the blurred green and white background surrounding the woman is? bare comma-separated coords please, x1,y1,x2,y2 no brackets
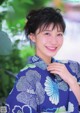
0,0,80,105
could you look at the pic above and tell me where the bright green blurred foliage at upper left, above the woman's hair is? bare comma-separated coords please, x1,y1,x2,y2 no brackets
0,0,52,35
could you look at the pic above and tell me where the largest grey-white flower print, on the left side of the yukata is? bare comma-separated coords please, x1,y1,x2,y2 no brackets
16,70,45,110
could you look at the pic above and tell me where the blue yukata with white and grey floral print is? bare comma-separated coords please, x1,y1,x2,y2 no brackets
6,56,80,113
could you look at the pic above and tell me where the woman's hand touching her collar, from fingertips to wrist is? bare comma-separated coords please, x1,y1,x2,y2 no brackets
47,62,74,84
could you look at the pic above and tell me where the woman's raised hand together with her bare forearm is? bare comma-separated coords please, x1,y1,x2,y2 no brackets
47,63,80,105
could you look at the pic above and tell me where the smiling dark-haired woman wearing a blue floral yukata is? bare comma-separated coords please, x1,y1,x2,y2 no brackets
6,7,80,113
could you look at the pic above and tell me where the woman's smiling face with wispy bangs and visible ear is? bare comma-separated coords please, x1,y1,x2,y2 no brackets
30,24,63,58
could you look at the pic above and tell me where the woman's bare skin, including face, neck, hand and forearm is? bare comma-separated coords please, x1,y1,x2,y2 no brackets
29,24,80,104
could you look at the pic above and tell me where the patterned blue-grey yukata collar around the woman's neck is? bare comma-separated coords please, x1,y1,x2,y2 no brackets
28,55,54,70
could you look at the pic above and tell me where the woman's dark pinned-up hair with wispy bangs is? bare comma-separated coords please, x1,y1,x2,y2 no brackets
24,7,65,37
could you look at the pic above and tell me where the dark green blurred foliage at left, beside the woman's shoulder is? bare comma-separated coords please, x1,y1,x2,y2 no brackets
0,40,34,103
